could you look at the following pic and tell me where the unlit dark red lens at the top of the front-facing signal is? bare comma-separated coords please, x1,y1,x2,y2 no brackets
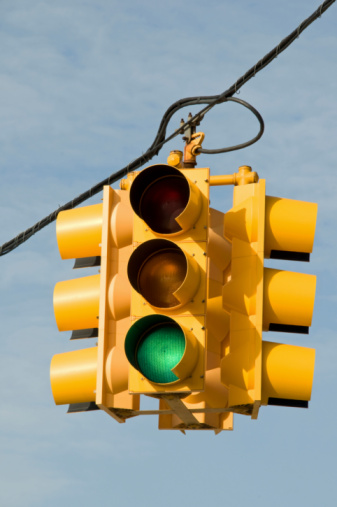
140,175,189,234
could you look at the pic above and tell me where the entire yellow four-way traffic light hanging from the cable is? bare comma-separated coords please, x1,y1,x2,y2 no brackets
51,128,317,433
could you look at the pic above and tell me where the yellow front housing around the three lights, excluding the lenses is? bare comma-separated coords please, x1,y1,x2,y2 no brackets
129,166,209,395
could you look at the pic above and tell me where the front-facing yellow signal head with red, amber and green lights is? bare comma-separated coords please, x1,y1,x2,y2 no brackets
125,164,209,395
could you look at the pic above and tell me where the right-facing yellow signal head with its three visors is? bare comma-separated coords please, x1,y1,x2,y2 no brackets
221,173,317,418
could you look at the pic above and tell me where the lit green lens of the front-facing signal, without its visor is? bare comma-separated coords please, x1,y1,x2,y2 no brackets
135,323,185,384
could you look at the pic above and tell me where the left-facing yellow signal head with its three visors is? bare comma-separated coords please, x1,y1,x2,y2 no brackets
50,186,139,422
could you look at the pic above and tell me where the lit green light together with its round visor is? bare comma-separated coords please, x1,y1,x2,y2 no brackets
125,315,186,384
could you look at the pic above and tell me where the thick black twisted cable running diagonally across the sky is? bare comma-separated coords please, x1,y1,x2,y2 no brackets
0,0,335,256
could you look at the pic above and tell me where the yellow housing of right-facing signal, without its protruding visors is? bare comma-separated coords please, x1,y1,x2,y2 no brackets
221,180,265,413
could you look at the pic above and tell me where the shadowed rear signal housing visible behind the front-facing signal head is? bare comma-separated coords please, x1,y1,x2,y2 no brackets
159,209,233,433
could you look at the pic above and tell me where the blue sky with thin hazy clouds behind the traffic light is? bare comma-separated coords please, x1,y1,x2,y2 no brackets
0,0,337,507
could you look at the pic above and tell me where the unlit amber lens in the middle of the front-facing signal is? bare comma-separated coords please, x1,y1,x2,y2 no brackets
138,249,187,308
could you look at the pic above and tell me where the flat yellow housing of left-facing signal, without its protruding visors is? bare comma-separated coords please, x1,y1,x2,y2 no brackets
95,186,139,416
